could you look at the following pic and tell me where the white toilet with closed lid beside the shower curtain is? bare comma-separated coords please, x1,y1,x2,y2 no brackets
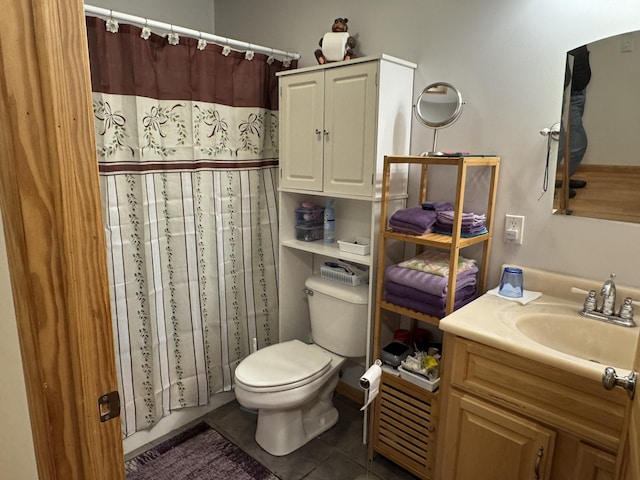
235,276,368,456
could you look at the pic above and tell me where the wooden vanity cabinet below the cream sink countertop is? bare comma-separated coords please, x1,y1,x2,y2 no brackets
436,334,628,480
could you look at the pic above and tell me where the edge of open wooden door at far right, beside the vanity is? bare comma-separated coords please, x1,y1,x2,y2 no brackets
615,330,640,480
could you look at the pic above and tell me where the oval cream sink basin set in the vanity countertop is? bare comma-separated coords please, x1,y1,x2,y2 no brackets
513,312,638,369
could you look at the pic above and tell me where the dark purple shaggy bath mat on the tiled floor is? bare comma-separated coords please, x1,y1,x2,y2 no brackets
125,422,278,480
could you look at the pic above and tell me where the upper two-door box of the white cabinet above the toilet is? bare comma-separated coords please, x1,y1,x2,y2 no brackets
280,55,415,197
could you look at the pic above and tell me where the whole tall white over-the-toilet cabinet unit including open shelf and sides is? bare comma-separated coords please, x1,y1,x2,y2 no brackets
278,55,416,381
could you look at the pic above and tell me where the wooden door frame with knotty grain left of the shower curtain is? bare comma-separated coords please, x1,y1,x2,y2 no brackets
0,0,124,480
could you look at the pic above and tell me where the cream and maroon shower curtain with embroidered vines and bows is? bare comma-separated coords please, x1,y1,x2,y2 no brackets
86,17,296,436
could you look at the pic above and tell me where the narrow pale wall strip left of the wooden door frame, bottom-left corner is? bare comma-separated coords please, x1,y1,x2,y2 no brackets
0,218,38,480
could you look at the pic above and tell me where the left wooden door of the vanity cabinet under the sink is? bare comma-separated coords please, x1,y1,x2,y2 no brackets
438,391,555,480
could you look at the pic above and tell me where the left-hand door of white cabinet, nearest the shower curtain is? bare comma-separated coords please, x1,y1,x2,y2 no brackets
280,72,326,191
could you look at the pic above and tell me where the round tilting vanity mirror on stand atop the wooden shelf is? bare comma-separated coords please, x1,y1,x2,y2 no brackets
413,82,464,155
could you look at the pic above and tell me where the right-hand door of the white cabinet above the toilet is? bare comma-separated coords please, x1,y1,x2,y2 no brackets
324,62,378,195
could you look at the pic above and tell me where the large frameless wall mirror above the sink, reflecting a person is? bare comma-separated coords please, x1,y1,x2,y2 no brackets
553,32,640,223
